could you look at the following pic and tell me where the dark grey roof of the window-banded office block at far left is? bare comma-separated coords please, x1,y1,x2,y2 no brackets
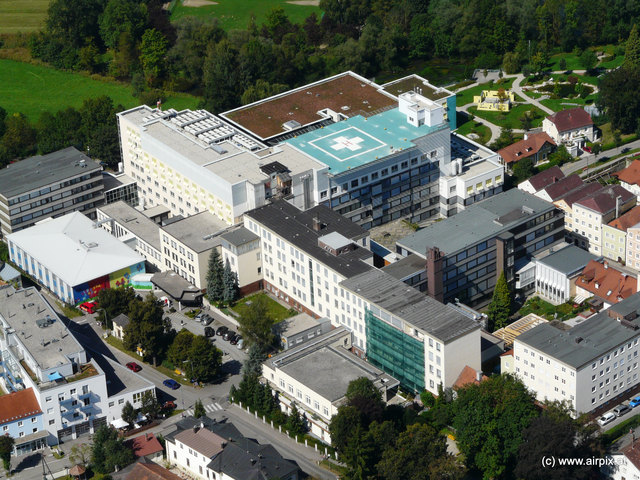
0,147,102,198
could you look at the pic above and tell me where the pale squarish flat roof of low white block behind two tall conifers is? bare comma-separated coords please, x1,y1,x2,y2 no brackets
162,212,229,253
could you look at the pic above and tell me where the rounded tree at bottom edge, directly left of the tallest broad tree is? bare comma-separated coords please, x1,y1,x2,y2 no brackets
377,424,466,480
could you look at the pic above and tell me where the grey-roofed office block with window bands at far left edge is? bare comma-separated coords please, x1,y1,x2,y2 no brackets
0,147,104,236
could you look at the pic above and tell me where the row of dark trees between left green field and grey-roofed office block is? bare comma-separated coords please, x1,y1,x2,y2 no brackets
0,96,124,168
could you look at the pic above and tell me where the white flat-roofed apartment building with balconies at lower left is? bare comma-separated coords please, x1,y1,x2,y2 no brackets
0,286,155,445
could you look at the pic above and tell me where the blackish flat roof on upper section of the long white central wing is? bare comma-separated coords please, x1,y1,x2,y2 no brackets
245,200,373,278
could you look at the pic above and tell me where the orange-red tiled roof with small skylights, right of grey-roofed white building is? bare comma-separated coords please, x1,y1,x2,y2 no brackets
576,260,638,304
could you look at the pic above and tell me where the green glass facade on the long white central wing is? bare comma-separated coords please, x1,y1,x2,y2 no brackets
365,309,425,392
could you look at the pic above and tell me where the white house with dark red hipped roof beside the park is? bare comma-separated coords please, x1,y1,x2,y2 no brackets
542,107,596,147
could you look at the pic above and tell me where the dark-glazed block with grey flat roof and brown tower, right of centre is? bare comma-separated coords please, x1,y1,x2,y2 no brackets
396,189,564,306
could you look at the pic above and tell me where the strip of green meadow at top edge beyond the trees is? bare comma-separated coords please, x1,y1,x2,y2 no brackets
170,0,321,30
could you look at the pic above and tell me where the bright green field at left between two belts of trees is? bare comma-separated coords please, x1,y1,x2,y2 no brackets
0,59,198,121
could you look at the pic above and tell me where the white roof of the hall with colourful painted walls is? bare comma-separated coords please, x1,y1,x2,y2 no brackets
7,212,144,286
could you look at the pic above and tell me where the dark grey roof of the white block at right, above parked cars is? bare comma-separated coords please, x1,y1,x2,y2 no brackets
516,293,640,369
